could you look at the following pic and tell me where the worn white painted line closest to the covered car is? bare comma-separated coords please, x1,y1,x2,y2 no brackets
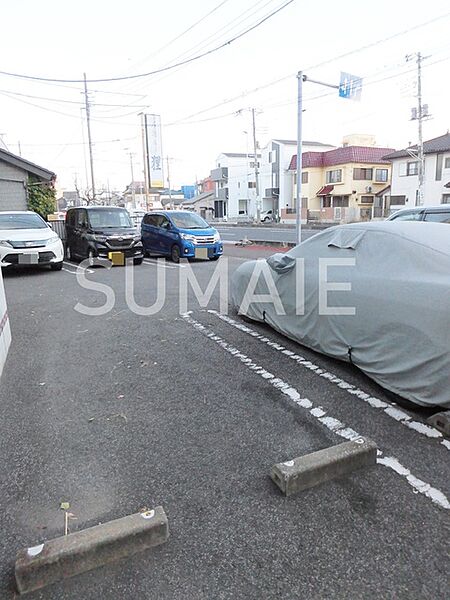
208,310,450,450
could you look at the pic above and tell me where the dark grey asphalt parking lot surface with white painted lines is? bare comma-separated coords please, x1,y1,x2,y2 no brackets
0,246,450,600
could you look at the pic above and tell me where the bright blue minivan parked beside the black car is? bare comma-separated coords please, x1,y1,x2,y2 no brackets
141,210,223,262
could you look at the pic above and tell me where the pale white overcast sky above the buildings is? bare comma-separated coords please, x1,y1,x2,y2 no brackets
0,0,450,190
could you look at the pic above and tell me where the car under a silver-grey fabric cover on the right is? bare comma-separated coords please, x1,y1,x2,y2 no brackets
231,221,450,407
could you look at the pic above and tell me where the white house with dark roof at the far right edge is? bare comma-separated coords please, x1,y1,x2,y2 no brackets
385,132,450,212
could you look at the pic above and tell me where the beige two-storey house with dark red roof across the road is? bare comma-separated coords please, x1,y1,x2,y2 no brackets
288,136,392,223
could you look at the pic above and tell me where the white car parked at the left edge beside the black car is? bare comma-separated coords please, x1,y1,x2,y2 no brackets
0,211,64,271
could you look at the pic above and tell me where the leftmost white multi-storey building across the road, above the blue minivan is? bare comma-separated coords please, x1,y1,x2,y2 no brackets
211,152,261,221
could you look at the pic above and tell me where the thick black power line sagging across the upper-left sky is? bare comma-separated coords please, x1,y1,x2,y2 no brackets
0,0,294,83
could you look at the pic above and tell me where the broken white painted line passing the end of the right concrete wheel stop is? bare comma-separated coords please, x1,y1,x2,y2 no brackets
182,314,450,510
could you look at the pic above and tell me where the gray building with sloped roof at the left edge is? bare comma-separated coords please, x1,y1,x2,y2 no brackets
0,148,56,210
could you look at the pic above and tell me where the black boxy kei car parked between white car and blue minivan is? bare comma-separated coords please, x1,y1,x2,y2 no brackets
66,206,144,265
